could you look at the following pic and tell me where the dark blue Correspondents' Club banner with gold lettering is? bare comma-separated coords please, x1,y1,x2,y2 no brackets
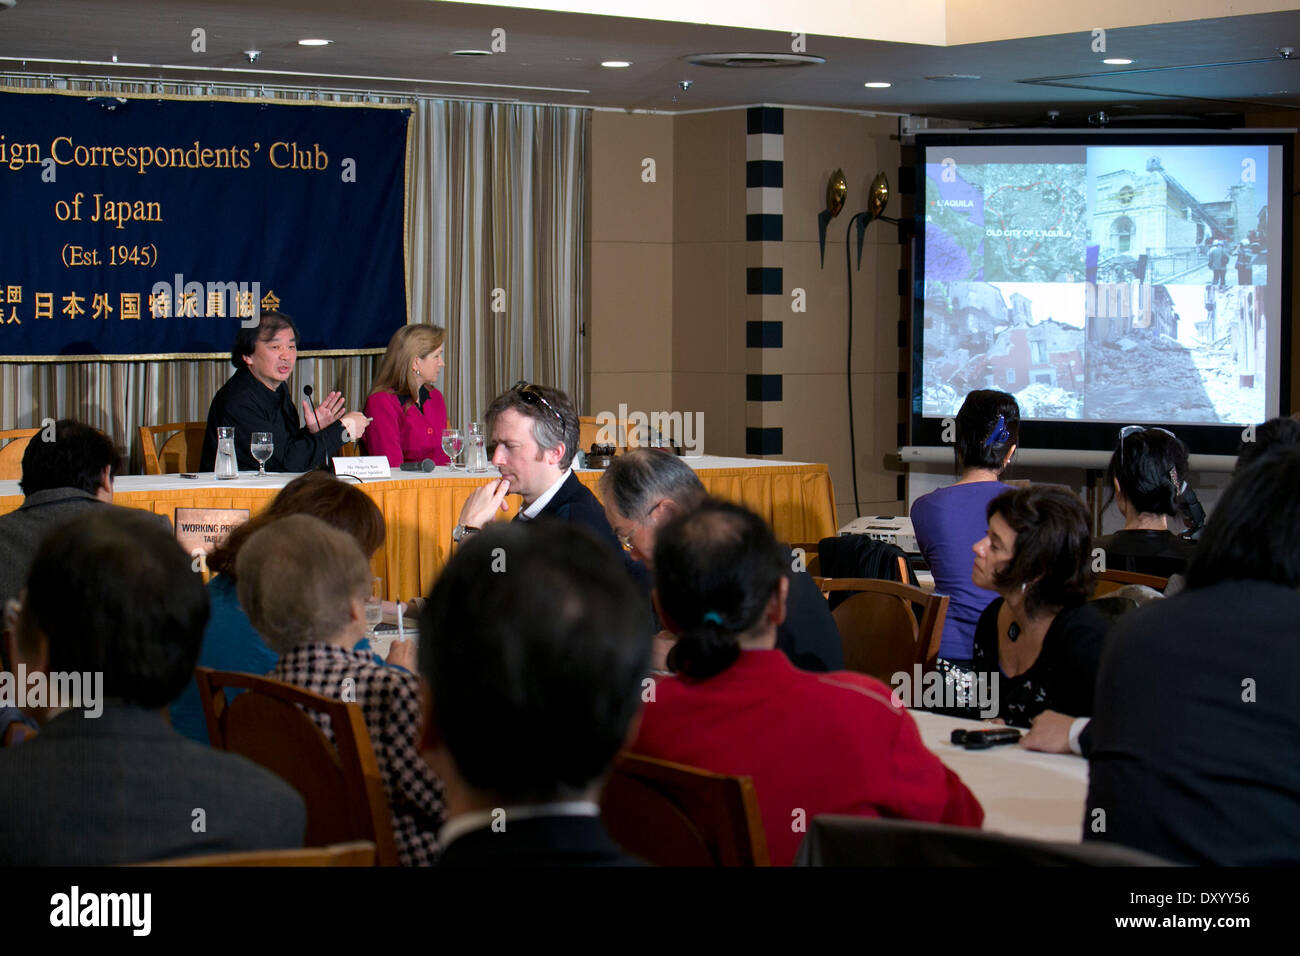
0,92,411,360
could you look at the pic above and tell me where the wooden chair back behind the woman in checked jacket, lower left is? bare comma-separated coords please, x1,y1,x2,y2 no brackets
194,667,398,866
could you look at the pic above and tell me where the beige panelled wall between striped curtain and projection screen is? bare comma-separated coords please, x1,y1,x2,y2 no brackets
588,109,902,523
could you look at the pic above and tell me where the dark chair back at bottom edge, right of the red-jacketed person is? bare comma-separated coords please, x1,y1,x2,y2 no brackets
794,814,1169,866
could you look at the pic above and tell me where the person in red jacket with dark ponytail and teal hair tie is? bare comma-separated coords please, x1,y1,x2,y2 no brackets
631,501,984,865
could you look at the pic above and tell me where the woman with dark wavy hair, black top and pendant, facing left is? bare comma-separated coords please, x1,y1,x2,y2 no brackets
971,485,1109,736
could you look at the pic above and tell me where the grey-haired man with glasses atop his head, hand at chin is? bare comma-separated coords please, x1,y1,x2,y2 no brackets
451,382,623,554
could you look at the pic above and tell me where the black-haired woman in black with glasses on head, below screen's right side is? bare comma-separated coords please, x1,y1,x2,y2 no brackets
1095,425,1195,578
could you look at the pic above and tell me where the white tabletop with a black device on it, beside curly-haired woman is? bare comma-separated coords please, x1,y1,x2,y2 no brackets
911,710,1088,843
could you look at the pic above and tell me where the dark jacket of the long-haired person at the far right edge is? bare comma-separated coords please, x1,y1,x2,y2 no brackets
1083,580,1300,866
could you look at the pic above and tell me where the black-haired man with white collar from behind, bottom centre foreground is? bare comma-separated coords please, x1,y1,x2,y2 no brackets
420,522,650,866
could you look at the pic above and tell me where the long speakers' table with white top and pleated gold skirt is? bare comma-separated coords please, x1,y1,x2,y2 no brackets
0,455,837,601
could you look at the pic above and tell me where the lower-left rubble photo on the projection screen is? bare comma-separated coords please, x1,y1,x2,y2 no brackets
922,281,1086,419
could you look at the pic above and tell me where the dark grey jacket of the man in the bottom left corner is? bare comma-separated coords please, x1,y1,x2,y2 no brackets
0,702,307,866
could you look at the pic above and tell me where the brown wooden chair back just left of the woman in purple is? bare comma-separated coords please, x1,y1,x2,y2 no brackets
813,578,948,684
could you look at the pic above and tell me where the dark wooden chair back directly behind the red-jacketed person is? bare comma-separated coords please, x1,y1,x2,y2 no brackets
601,753,768,866
